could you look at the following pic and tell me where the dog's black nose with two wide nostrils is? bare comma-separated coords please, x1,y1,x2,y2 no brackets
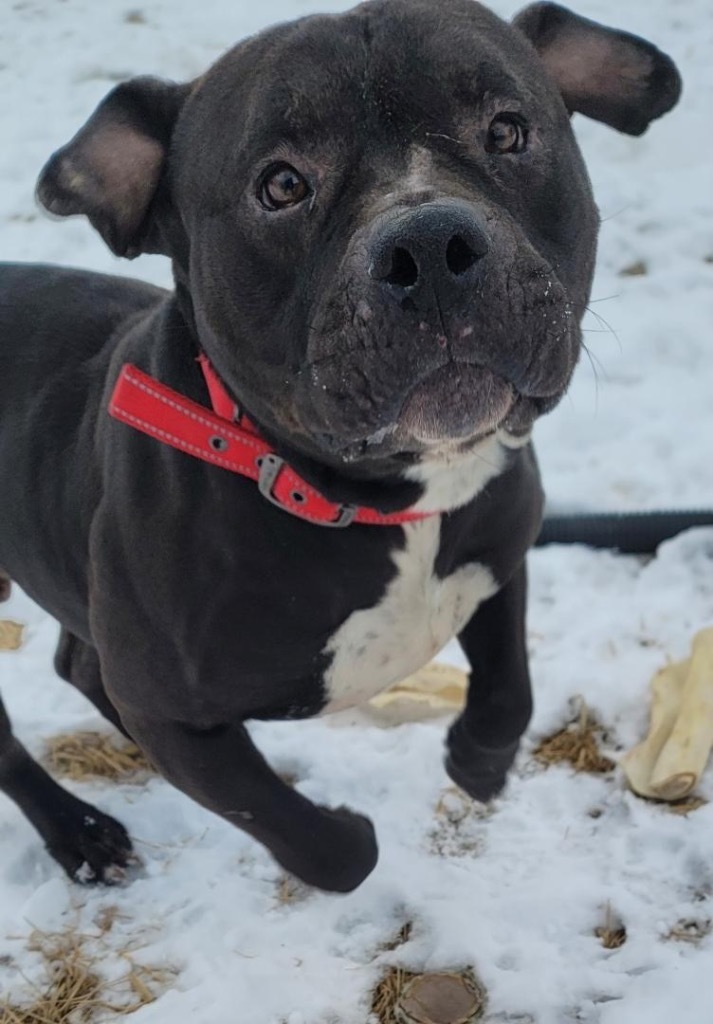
369,203,489,298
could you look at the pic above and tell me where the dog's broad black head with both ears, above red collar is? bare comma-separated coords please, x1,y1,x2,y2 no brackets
39,0,680,475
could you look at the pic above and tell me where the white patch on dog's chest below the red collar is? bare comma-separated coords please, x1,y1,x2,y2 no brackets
324,516,497,713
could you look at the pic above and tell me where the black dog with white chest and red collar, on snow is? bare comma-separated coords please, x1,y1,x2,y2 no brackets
0,0,680,891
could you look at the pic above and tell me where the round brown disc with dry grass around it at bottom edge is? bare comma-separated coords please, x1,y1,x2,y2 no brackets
371,967,487,1024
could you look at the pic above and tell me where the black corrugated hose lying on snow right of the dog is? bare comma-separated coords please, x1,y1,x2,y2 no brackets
535,509,713,555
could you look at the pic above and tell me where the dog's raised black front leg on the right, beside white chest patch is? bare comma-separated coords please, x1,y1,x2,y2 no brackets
446,564,533,801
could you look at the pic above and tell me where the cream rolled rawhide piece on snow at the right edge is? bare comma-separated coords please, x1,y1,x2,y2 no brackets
621,627,713,800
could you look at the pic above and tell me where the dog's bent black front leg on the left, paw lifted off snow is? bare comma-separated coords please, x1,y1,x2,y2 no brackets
122,713,377,892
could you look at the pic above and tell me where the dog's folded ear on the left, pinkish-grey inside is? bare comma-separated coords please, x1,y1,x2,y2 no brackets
37,78,191,259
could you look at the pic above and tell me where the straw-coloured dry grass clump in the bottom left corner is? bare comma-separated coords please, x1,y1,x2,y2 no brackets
0,926,174,1024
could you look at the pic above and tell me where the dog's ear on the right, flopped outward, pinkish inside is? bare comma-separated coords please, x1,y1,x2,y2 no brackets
512,3,681,135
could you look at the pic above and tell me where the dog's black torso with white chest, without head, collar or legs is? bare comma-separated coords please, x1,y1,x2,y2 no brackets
0,266,541,712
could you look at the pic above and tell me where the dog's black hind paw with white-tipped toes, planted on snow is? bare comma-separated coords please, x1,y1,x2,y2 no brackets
47,805,139,886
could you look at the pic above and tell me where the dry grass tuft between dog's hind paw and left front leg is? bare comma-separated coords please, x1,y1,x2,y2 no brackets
43,732,154,782
